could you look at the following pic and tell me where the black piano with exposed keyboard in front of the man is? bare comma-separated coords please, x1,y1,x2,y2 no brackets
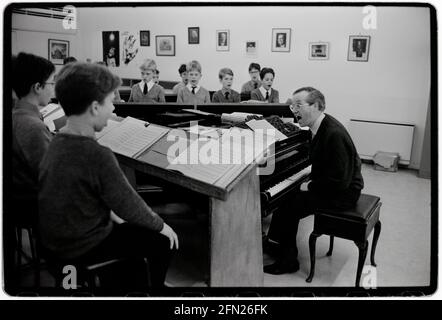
115,103,311,217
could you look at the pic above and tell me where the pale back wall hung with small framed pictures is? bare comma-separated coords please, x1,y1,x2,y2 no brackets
12,7,430,168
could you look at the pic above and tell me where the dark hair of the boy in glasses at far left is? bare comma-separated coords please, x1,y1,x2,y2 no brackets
12,52,55,98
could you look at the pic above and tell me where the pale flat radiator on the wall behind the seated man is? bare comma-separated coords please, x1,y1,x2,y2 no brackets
348,119,414,165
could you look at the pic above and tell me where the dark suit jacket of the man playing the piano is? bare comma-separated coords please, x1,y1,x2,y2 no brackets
308,114,364,204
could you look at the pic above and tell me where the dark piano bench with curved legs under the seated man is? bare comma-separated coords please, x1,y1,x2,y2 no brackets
306,194,382,287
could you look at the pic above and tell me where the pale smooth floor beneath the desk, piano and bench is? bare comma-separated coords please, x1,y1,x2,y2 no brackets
14,164,431,294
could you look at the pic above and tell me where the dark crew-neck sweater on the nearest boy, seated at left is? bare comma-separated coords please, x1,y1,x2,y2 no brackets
39,133,163,259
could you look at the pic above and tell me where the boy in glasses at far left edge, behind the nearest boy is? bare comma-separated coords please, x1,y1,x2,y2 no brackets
12,52,55,221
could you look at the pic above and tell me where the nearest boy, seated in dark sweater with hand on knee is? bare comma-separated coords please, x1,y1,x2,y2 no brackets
39,63,178,287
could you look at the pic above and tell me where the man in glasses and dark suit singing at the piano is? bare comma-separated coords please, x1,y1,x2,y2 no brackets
264,87,364,274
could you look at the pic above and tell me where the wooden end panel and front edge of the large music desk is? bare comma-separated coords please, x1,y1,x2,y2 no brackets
116,154,264,287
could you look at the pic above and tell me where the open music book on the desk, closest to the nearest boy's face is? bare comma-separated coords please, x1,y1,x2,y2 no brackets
97,117,169,158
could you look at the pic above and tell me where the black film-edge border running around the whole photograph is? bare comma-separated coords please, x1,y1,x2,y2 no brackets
2,2,439,298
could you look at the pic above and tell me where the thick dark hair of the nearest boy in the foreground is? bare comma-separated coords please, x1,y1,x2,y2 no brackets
55,62,121,116
